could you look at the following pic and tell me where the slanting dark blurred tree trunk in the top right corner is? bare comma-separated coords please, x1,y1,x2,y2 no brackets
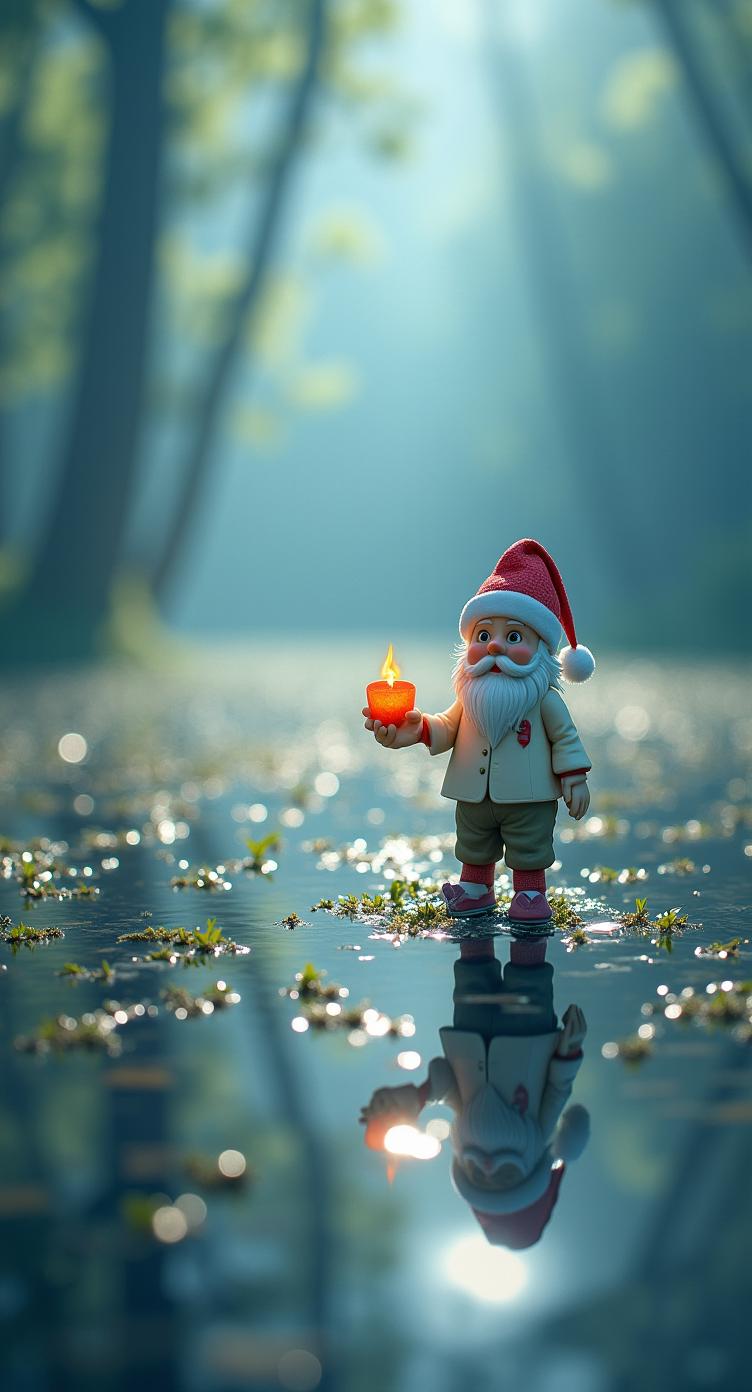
653,0,752,256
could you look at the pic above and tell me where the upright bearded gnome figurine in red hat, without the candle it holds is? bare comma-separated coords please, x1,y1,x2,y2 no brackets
363,539,595,924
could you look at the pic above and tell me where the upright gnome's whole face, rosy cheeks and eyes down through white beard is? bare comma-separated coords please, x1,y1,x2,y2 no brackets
453,617,560,746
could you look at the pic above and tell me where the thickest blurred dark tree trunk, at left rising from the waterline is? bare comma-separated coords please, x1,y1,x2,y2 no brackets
6,0,170,658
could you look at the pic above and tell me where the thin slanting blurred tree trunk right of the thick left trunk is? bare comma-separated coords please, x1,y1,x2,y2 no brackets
152,0,327,600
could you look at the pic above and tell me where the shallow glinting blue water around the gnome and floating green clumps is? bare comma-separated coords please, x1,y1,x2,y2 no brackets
0,636,752,1392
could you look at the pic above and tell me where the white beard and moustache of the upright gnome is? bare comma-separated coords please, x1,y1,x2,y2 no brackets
451,640,561,749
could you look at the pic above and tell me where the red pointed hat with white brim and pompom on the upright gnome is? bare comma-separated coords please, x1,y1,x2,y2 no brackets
460,537,595,682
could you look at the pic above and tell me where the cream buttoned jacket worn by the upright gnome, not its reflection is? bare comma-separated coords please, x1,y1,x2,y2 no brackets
426,686,590,802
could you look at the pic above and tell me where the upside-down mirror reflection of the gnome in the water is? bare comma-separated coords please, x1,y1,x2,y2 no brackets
361,937,589,1249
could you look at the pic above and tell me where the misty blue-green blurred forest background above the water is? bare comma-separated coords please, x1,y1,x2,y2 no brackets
0,0,752,664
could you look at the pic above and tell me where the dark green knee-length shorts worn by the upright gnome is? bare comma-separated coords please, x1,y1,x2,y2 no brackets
454,793,558,870
